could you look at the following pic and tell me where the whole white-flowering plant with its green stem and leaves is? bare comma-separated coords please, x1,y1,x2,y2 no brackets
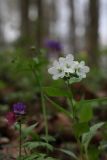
44,54,107,160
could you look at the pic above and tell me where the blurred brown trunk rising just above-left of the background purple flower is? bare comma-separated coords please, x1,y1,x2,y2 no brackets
34,0,51,50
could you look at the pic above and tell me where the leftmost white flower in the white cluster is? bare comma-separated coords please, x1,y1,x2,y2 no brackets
48,60,65,80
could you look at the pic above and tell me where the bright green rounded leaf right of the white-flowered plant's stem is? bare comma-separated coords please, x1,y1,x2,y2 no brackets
77,105,93,122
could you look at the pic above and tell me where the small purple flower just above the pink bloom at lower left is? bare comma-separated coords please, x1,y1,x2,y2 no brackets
13,102,26,115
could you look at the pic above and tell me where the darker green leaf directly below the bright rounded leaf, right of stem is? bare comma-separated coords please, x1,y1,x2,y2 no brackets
73,123,89,137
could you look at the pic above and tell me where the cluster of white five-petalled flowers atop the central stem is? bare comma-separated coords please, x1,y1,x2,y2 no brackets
48,54,89,80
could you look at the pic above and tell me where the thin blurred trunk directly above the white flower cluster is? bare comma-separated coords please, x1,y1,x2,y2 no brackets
69,0,76,53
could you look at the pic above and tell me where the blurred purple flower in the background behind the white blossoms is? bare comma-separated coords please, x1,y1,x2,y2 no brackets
45,40,62,52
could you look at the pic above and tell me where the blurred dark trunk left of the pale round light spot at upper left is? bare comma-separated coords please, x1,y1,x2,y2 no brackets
20,0,30,45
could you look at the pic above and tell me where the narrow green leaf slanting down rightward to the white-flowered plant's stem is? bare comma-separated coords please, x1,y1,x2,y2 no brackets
45,96,73,118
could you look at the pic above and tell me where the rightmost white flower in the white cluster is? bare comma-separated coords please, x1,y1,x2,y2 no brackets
76,61,90,79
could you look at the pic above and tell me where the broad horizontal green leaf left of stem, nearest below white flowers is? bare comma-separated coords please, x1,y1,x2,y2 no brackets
43,87,69,97
